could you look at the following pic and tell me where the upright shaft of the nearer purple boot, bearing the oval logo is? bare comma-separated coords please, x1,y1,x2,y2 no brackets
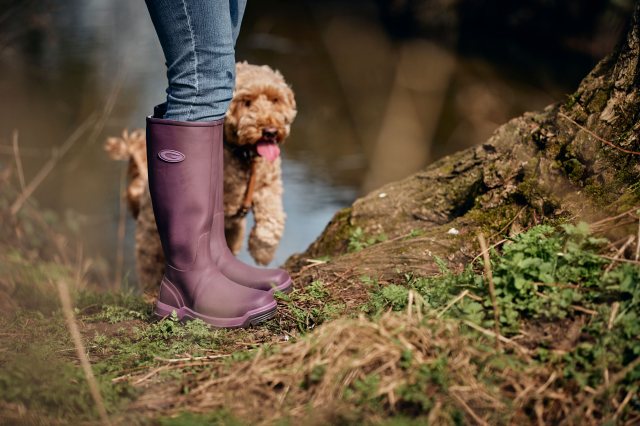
147,117,223,270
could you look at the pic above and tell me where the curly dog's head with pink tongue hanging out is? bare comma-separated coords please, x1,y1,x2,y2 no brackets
224,62,297,161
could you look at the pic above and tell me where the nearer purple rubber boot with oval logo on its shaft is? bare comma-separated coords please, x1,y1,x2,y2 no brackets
147,111,276,328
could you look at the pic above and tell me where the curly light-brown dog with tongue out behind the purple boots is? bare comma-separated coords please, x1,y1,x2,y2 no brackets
105,62,296,297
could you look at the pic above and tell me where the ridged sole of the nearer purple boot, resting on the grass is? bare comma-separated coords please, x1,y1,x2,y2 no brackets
155,301,277,328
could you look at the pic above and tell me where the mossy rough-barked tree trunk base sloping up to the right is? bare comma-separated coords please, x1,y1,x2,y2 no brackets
287,3,640,308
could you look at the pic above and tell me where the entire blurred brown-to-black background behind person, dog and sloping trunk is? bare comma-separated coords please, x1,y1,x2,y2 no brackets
0,0,633,286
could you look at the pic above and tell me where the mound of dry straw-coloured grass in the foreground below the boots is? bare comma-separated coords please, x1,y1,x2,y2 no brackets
136,313,569,424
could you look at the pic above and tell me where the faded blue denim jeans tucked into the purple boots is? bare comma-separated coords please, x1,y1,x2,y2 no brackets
145,0,247,121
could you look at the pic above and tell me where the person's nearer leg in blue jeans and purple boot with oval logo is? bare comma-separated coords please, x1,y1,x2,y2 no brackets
147,0,276,327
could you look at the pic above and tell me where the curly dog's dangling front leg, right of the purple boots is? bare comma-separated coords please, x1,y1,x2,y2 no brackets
249,169,285,265
